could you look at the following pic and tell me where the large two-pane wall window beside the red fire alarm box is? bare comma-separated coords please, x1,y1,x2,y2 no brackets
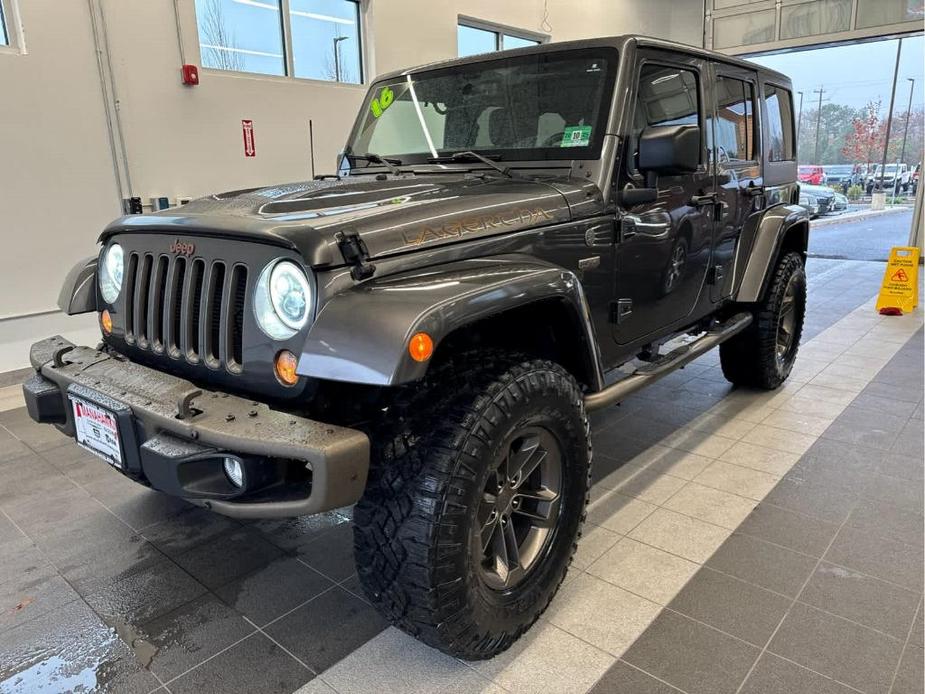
196,0,363,84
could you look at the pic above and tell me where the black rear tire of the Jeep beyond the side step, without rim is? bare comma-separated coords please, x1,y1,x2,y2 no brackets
719,253,806,390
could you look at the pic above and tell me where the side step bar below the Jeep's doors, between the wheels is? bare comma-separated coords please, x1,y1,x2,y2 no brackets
585,313,753,412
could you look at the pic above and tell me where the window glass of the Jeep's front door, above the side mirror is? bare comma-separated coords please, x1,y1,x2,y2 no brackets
630,63,702,171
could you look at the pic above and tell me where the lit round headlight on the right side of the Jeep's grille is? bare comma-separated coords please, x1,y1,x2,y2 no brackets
254,260,313,340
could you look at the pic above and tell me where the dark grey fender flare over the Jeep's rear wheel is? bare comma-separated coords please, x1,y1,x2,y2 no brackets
736,205,809,303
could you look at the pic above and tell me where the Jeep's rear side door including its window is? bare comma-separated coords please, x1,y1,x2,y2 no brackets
707,63,764,301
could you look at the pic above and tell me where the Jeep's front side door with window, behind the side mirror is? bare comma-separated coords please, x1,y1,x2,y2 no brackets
611,50,714,345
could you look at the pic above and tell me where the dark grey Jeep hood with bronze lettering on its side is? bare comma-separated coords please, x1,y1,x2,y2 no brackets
100,173,584,267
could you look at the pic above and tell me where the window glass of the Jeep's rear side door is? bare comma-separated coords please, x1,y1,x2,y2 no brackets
713,76,755,164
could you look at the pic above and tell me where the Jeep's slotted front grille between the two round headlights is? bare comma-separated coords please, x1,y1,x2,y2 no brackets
125,251,247,373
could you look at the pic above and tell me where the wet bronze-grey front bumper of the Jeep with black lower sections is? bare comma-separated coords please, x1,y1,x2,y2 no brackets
23,337,369,518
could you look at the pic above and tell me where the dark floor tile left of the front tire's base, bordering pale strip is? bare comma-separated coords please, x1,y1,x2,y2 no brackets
264,588,387,672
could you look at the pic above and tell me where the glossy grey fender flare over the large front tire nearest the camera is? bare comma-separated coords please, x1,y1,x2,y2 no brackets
298,256,603,388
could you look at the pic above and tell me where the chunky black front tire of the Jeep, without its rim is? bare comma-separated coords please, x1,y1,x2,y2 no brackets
353,354,591,660
